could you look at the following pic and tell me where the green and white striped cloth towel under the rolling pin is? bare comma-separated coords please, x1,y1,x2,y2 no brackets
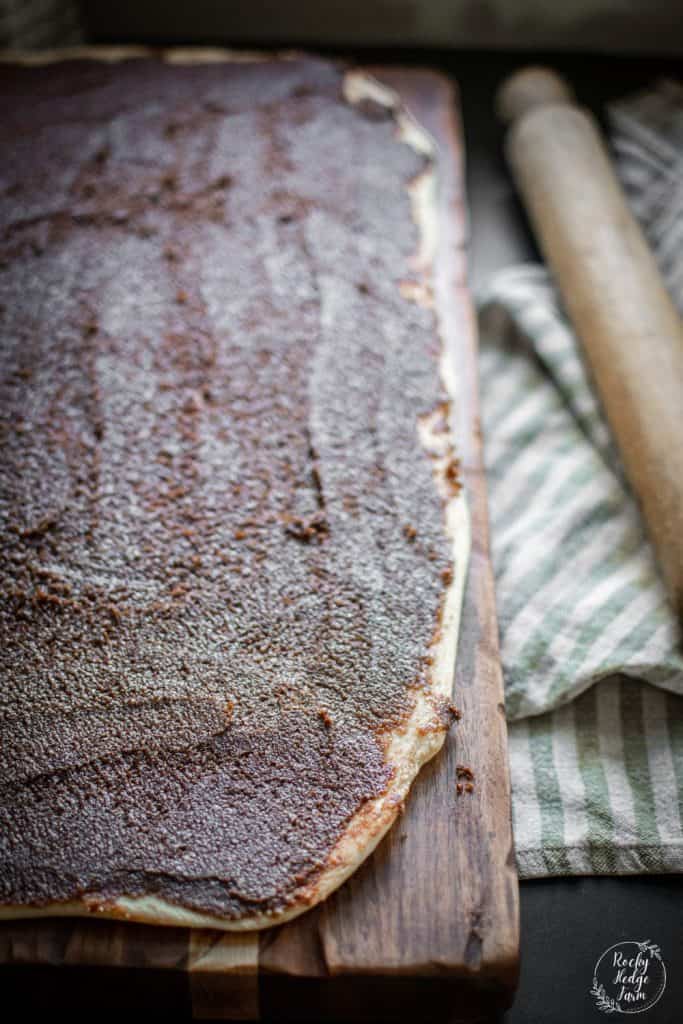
480,83,683,878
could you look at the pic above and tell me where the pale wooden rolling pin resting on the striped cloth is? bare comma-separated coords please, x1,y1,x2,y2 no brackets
498,68,683,623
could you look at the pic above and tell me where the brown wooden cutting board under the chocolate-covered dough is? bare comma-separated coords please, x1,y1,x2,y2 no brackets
0,59,518,1021
